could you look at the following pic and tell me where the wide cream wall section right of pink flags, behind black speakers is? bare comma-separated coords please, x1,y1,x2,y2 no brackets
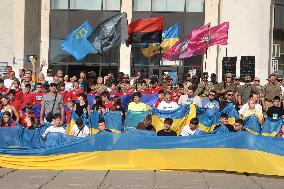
205,0,271,83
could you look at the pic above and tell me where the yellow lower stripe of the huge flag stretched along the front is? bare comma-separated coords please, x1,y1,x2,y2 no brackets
0,148,284,176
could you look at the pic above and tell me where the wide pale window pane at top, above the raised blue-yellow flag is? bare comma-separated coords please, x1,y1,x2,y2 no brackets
152,0,185,12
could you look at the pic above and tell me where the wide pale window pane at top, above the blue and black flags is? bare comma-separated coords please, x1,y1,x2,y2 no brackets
70,0,102,10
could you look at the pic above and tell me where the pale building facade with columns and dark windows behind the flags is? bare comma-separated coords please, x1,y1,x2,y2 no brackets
0,0,284,82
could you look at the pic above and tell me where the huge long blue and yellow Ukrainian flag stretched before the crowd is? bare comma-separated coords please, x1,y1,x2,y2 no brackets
0,127,284,176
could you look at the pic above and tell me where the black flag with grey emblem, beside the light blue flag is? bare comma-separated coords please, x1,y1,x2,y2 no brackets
88,12,128,54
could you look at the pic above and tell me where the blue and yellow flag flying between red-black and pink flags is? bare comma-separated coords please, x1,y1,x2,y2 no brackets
142,23,180,57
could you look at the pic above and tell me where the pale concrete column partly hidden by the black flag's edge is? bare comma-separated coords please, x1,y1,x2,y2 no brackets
119,0,132,75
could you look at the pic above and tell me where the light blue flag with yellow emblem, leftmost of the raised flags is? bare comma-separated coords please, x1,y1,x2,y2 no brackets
61,21,97,61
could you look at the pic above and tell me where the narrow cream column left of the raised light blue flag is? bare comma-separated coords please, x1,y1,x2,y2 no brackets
39,0,50,75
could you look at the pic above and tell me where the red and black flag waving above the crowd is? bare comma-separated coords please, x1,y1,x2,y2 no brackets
128,17,164,44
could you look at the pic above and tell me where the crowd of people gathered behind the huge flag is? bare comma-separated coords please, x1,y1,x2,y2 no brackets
0,62,284,137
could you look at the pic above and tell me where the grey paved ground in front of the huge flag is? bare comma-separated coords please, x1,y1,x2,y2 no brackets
0,169,284,189
